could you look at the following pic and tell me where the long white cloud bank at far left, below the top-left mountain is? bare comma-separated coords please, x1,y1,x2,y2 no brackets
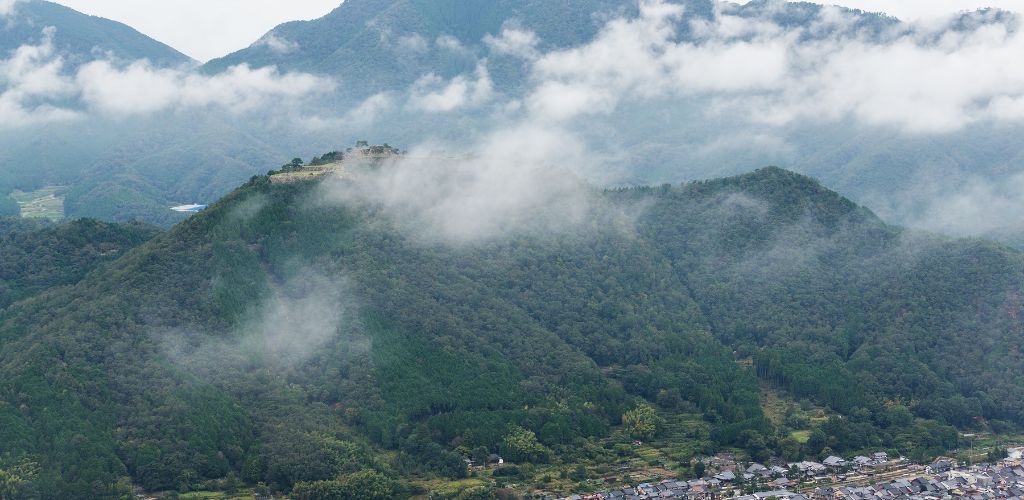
0,28,335,128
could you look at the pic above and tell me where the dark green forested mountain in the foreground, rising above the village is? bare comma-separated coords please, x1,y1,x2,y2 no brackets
0,168,1024,498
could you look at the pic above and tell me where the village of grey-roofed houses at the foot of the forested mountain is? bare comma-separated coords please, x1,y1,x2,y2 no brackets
562,448,1024,500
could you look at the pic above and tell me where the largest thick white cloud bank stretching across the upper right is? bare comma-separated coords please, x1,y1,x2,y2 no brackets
503,0,1024,133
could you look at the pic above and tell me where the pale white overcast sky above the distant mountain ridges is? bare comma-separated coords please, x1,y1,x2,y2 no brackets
55,0,1024,61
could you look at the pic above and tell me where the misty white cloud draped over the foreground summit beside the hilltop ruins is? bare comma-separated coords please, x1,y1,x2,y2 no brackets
323,125,594,245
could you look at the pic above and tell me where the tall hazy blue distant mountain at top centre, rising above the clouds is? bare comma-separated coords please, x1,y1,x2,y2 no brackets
204,0,637,99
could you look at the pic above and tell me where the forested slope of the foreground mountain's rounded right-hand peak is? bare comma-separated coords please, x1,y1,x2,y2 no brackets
630,170,1024,434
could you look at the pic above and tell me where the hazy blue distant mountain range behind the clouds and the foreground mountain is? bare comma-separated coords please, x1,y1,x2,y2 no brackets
0,0,1024,246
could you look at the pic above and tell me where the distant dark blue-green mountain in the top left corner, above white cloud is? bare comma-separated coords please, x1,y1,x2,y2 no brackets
0,0,193,68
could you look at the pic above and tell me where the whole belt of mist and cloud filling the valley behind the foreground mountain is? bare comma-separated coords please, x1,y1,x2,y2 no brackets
6,0,1024,241
